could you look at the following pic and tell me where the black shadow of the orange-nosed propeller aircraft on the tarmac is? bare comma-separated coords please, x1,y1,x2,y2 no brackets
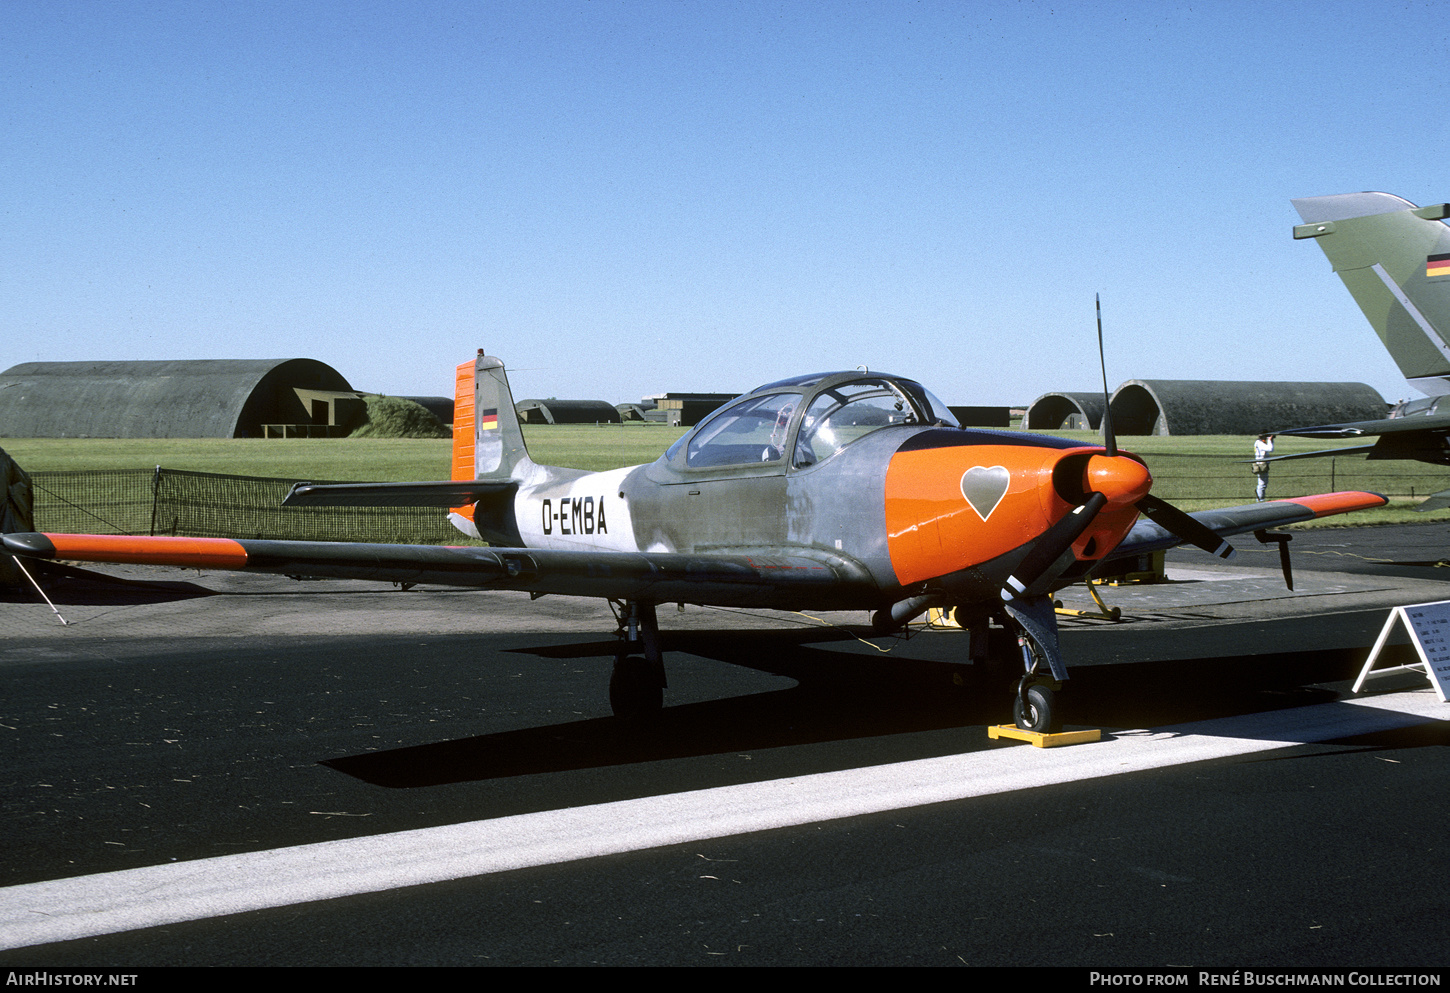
322,631,1403,789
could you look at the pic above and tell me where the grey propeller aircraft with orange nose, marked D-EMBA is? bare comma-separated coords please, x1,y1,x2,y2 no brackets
4,324,1385,731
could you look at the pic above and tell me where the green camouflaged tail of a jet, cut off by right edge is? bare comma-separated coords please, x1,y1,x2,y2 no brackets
1266,193,1450,510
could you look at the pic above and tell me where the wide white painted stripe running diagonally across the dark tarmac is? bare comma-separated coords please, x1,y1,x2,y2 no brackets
0,689,1450,948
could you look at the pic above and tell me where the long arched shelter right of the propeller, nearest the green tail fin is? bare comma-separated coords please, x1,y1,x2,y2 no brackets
1102,380,1386,435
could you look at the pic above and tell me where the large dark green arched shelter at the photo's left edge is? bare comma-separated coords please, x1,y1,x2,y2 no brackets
0,358,367,438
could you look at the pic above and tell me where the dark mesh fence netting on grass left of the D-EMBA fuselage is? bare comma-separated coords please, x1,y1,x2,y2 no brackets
30,467,464,545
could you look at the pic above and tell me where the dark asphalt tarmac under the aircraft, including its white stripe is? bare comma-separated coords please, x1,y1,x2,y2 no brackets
0,525,1450,973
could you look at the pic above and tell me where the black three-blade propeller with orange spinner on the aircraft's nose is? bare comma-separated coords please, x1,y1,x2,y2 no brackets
1002,299,1234,600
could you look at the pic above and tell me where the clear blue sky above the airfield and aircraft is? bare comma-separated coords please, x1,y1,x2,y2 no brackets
0,0,1450,404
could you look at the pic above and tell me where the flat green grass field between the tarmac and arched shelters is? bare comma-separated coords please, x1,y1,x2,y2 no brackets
8,423,1450,525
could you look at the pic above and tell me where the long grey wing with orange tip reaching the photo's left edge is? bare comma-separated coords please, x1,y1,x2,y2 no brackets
0,533,880,610
